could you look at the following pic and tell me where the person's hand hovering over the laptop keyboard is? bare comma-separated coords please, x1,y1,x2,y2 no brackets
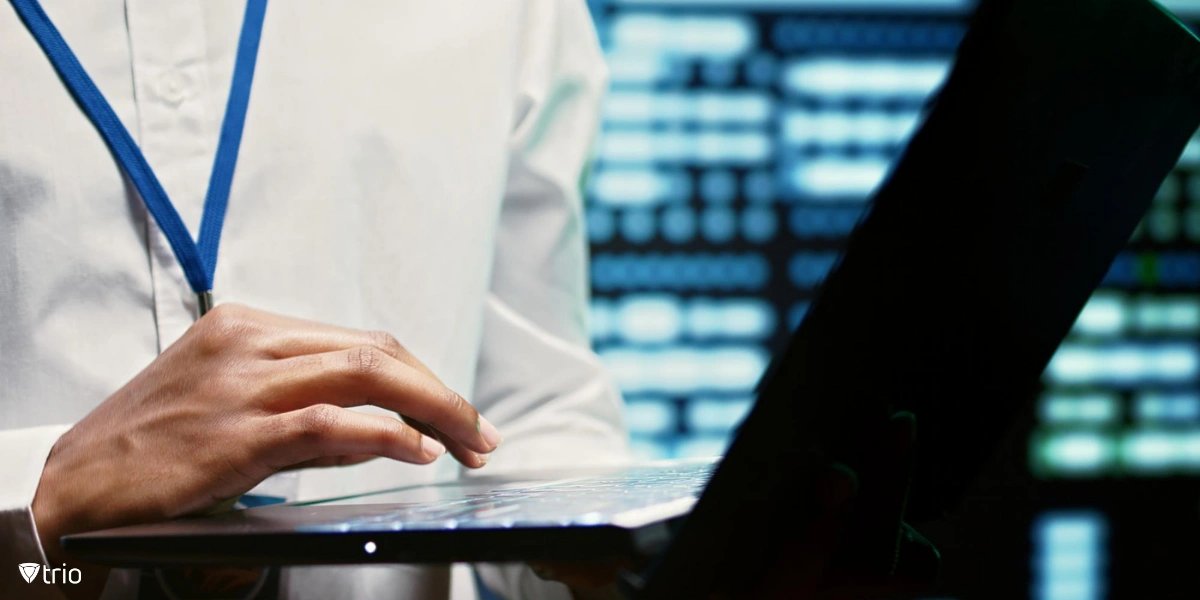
32,305,500,563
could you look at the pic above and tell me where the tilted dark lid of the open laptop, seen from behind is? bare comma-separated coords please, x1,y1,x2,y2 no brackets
643,0,1200,597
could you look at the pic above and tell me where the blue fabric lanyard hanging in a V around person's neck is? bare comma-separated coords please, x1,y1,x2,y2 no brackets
11,0,266,316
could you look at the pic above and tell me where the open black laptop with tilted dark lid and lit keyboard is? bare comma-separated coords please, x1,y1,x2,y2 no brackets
64,0,1200,599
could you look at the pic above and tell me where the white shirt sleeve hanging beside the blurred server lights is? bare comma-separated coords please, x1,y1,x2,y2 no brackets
472,0,630,600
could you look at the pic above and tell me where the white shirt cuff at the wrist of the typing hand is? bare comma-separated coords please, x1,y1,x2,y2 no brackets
0,425,71,600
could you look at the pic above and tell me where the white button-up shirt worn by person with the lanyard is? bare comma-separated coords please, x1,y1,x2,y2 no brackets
0,0,626,600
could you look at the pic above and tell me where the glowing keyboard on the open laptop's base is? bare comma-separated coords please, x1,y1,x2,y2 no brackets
306,462,718,532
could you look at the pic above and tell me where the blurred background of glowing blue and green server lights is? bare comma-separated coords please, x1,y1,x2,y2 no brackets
576,0,1200,600
